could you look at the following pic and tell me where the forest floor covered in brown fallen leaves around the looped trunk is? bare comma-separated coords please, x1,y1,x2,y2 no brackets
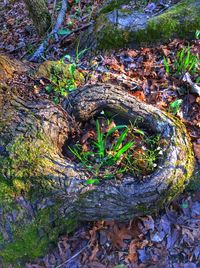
0,0,200,268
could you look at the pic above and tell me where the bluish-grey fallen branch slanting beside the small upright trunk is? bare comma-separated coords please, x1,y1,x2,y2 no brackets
30,0,67,61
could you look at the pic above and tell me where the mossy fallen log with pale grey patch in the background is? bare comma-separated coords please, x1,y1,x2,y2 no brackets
80,0,200,53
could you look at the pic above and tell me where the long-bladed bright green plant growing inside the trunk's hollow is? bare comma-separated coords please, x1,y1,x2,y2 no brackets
68,120,134,184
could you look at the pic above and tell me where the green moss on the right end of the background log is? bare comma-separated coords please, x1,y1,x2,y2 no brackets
135,0,200,45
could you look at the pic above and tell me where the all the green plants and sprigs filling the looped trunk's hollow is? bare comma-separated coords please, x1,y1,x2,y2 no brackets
68,120,159,184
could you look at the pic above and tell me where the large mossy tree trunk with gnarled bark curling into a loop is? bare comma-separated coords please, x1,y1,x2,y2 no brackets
0,80,194,267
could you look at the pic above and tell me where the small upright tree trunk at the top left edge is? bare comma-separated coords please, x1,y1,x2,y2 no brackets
24,0,51,35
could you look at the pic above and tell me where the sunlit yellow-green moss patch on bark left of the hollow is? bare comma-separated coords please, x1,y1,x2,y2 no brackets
0,136,51,188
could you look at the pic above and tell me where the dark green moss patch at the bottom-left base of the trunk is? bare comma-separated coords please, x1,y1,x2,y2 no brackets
0,206,77,267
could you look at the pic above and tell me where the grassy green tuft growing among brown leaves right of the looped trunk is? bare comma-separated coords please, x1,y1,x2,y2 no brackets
163,46,199,76
